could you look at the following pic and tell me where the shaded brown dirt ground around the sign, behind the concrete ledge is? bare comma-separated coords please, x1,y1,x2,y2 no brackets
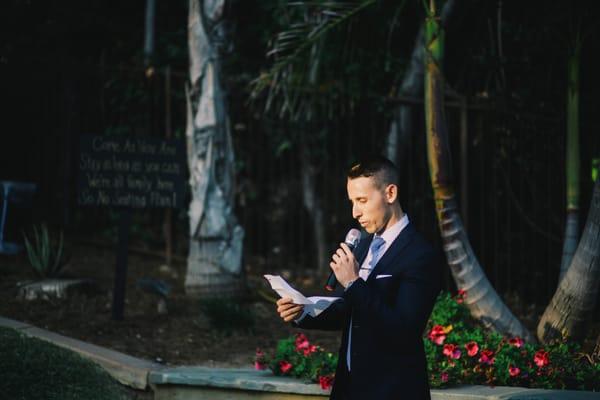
0,241,339,367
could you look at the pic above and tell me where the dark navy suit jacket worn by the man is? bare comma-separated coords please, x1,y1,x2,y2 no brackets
298,223,441,400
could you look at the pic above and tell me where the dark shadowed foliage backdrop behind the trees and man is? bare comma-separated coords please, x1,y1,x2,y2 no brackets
0,0,600,312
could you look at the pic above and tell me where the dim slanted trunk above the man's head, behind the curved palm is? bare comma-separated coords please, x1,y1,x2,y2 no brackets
385,0,456,170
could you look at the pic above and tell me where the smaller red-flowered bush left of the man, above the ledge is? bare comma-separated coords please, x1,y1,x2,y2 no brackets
254,333,337,389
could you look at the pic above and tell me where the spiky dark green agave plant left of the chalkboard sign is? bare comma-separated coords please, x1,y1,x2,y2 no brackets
23,224,67,278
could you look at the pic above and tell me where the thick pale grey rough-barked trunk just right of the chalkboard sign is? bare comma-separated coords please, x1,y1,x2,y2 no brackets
185,0,244,297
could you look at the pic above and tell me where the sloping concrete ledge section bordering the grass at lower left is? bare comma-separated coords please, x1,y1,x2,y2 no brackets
0,317,162,390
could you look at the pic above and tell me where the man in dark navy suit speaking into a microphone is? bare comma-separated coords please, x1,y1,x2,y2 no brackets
277,157,441,400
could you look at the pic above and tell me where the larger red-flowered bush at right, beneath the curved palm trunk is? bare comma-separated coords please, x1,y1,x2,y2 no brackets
425,291,600,390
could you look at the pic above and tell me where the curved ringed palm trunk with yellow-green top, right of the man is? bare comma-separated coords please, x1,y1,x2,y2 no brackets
425,1,535,342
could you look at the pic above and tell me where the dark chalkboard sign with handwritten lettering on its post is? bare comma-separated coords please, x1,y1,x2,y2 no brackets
77,135,186,320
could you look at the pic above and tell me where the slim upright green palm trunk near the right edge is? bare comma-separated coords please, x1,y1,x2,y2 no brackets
558,41,581,284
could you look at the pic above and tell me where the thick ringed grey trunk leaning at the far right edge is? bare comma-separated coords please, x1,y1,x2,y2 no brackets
537,180,600,343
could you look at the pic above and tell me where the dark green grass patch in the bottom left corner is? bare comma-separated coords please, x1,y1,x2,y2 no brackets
0,328,127,400
